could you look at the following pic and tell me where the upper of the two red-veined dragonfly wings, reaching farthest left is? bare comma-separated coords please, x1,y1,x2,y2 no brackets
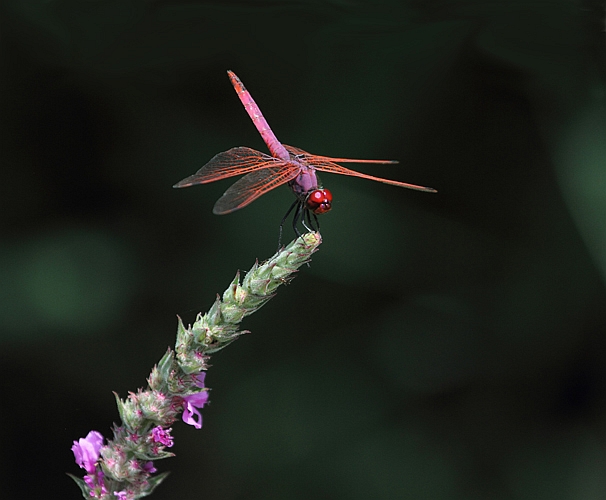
173,147,283,188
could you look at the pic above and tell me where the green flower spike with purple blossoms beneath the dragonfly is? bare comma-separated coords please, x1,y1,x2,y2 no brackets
70,233,322,500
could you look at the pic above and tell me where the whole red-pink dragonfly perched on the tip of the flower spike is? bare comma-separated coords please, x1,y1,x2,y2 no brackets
173,71,436,236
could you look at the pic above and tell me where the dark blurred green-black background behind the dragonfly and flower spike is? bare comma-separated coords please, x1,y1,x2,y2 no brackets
0,0,606,500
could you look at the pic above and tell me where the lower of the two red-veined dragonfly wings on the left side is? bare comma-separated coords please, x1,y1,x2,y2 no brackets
213,164,299,215
